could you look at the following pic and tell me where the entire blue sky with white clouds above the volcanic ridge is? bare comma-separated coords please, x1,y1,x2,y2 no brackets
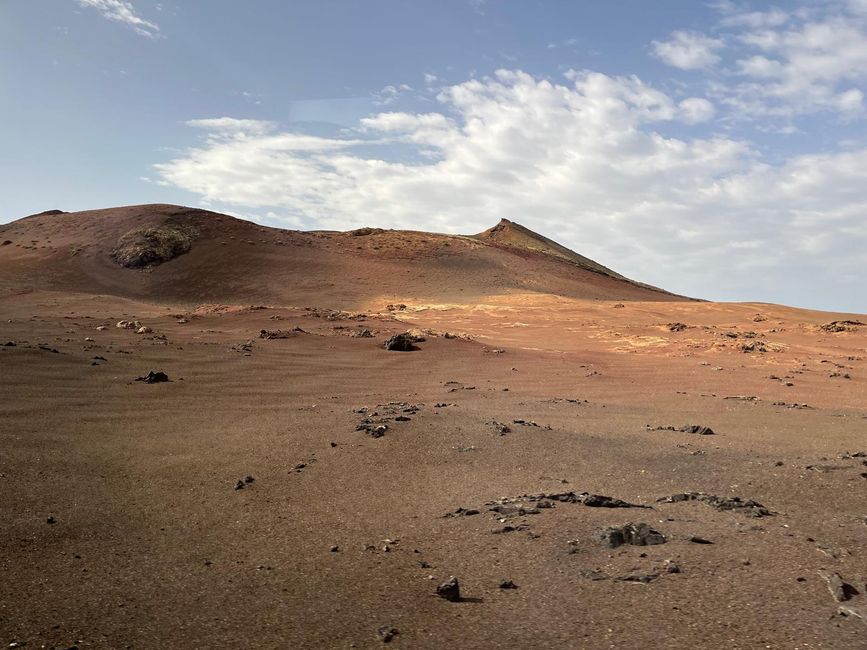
0,0,867,313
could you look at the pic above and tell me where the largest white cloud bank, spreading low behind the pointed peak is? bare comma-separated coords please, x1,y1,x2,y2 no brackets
156,70,867,303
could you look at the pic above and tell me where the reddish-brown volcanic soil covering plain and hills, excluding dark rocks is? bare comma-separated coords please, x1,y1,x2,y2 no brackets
0,206,867,649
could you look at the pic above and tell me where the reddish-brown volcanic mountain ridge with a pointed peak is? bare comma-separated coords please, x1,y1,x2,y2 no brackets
0,205,684,309
